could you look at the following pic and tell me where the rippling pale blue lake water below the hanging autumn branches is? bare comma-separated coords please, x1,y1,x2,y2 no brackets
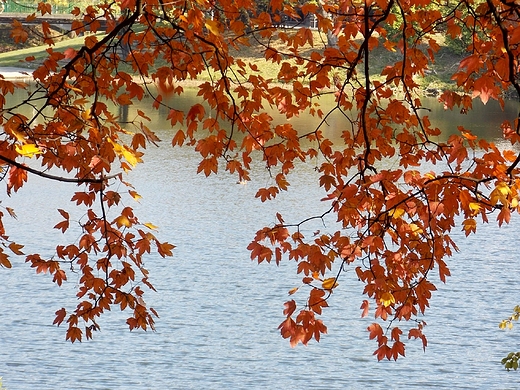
0,90,520,390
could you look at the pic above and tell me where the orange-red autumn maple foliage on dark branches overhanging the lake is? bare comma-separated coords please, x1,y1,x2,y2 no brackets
0,0,520,359
